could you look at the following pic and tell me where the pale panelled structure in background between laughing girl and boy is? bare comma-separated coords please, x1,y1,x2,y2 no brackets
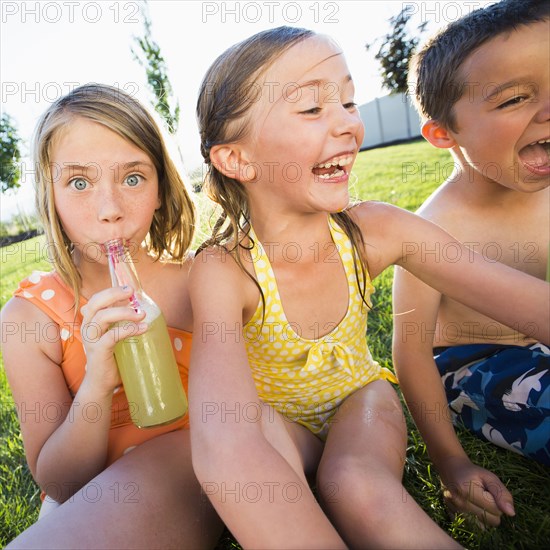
359,94,422,150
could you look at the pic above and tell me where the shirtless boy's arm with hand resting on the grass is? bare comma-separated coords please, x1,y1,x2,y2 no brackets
393,267,514,525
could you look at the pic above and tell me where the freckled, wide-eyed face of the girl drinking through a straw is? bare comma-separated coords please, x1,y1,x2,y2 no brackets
50,117,160,260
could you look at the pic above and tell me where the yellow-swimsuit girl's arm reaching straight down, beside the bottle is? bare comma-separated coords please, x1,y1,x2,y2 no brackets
189,250,345,548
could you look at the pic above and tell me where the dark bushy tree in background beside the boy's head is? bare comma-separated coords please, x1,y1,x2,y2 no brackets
365,8,427,94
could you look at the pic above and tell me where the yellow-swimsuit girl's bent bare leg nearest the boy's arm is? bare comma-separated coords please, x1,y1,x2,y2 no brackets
317,380,460,549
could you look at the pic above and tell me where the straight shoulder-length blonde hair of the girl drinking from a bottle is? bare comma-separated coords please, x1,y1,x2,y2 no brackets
33,84,195,307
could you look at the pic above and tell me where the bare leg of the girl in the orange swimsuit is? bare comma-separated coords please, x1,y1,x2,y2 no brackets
8,430,223,549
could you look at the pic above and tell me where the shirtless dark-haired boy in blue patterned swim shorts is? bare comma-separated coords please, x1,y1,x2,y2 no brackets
394,0,550,524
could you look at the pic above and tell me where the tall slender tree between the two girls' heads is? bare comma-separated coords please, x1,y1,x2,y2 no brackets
132,0,180,134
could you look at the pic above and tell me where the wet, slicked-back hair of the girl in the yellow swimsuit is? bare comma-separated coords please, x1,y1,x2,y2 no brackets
197,27,368,305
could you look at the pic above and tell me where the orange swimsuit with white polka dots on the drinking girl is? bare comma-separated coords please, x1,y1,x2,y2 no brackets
14,271,192,464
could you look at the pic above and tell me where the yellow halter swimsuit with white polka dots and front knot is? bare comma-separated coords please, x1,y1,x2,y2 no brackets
243,218,397,439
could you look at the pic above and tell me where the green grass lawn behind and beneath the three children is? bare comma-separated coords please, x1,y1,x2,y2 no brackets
0,141,550,550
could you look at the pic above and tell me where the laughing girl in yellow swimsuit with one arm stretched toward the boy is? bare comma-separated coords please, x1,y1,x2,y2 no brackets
189,27,549,548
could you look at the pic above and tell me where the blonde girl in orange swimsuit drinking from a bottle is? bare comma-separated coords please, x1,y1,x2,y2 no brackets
2,84,220,548
